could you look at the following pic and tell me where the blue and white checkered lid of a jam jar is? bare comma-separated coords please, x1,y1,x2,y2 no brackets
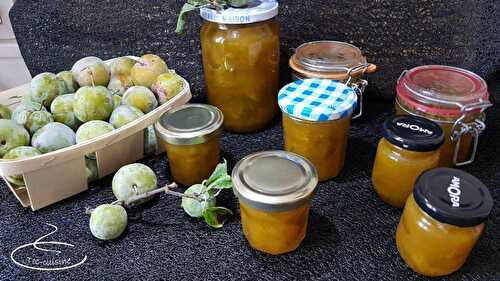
278,79,358,121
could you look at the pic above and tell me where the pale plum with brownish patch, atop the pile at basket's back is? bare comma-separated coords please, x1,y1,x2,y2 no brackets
71,57,110,87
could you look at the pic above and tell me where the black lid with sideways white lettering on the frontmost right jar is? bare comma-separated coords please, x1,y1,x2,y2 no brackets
413,168,493,227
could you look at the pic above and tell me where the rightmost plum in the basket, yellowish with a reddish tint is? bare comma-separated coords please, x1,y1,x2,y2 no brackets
151,70,184,104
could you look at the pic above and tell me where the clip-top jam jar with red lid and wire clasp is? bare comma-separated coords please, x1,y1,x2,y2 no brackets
396,65,492,167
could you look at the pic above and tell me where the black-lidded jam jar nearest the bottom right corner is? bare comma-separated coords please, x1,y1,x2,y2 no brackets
396,168,493,276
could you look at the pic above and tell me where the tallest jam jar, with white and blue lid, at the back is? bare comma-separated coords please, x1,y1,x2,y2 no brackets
201,0,280,133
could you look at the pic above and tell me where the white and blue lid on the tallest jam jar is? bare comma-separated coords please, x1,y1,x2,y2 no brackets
200,0,278,24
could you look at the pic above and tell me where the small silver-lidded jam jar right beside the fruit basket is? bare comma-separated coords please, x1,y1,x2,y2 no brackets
155,104,224,186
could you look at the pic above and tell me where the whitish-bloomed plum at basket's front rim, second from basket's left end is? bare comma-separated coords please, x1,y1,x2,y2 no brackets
31,122,76,153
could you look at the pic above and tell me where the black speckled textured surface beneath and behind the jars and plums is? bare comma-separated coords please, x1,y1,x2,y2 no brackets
0,0,500,281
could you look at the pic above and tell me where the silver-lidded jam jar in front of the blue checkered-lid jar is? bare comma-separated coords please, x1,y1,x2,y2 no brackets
232,151,318,255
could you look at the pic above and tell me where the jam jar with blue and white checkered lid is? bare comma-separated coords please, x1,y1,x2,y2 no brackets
278,79,357,181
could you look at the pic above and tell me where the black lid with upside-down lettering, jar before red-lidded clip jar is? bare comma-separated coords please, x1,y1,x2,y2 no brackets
382,115,444,152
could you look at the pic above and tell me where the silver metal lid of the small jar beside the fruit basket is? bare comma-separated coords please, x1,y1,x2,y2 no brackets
155,104,224,145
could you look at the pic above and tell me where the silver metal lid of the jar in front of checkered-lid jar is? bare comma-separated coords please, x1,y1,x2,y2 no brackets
232,150,318,212
